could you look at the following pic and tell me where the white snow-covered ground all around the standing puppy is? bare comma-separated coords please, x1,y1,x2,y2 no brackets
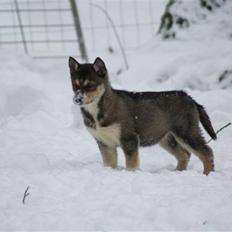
0,1,232,231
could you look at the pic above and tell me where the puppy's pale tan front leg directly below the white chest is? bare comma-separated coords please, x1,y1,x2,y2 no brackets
97,141,118,168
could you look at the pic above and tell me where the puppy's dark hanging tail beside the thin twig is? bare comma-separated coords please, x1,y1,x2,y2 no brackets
196,103,217,140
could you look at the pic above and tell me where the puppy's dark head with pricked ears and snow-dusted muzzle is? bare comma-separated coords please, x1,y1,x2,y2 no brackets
69,57,107,105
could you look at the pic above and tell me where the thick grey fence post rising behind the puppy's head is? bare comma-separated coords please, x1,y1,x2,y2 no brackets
70,0,88,62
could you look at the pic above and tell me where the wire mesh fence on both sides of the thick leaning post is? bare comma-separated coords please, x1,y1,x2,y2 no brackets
0,0,159,57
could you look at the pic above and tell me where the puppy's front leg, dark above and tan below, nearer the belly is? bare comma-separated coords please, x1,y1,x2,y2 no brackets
121,136,139,171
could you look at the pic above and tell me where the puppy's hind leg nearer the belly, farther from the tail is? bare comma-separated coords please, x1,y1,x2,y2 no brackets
159,133,191,171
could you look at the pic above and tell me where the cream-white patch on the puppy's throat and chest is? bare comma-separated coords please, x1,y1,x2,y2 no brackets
82,97,121,147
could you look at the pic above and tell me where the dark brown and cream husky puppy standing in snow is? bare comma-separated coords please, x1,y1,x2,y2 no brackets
69,57,216,175
